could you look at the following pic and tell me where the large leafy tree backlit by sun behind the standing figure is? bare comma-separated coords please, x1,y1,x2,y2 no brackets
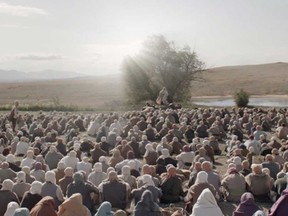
122,35,204,101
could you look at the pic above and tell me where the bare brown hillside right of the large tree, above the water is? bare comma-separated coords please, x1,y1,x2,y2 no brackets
192,63,288,96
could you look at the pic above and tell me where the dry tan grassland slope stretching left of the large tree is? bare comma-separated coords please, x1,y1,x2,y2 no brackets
0,75,124,109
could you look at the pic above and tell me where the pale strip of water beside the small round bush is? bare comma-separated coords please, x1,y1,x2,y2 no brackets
193,97,288,107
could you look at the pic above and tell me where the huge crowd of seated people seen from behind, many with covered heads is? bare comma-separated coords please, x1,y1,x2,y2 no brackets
0,106,288,216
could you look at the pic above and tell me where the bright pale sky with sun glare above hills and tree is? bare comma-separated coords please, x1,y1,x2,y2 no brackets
0,0,288,75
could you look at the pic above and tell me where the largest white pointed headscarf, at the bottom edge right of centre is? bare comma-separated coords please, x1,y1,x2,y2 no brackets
191,188,223,216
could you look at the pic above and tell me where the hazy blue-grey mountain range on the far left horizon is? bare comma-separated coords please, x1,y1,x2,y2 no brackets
0,69,86,83
